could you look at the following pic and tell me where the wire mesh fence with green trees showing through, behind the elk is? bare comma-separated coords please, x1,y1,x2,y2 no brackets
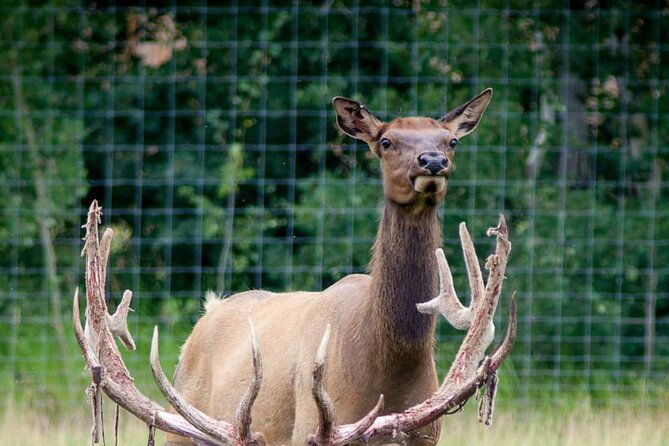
0,0,669,408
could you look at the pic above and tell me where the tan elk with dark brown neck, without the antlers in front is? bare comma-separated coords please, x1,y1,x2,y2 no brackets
168,92,490,445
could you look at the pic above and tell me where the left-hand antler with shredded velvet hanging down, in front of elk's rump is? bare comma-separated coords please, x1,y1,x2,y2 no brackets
72,201,264,446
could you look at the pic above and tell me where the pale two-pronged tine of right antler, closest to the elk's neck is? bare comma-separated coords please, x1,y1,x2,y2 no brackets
416,248,476,330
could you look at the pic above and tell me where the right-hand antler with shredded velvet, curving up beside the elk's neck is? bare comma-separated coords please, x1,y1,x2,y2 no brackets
310,214,516,445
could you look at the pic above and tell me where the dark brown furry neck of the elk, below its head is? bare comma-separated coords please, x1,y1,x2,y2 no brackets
368,200,442,362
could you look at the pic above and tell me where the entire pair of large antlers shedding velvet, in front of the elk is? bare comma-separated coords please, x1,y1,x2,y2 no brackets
72,201,516,446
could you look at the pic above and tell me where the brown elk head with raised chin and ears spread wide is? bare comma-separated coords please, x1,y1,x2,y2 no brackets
332,88,492,207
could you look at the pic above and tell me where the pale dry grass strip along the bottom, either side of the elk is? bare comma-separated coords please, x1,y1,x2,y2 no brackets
0,401,669,446
